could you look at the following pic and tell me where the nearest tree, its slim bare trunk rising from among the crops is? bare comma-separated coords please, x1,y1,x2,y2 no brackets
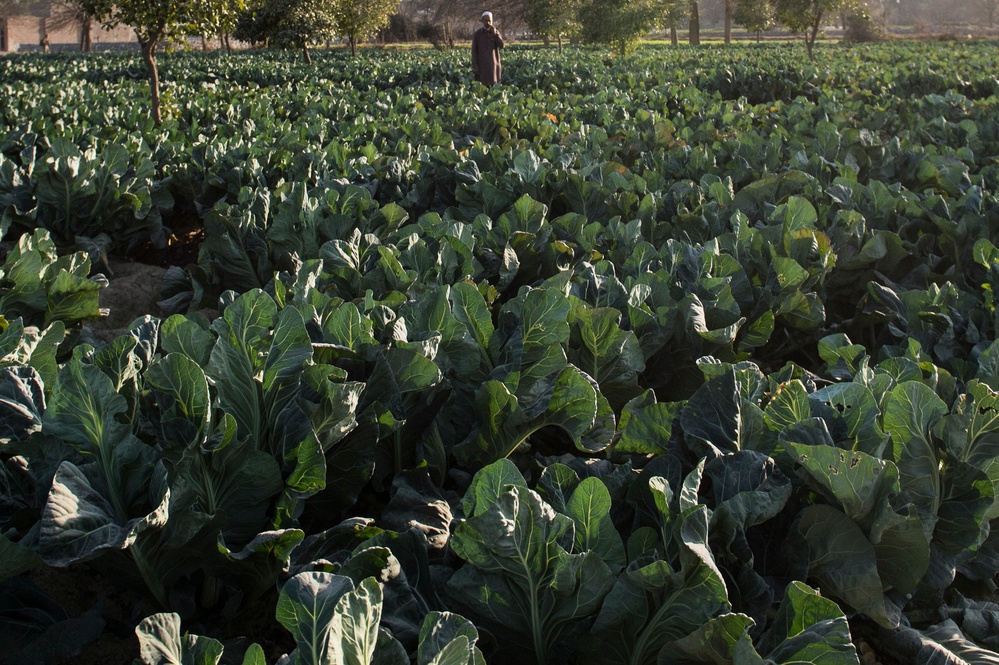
78,0,242,125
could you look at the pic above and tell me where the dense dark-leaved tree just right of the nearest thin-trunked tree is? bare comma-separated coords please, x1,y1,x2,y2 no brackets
235,0,335,64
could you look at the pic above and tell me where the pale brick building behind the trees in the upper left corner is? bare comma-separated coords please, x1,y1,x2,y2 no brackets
0,0,138,53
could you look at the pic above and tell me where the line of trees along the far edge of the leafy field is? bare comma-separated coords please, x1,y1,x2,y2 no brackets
11,0,999,123
